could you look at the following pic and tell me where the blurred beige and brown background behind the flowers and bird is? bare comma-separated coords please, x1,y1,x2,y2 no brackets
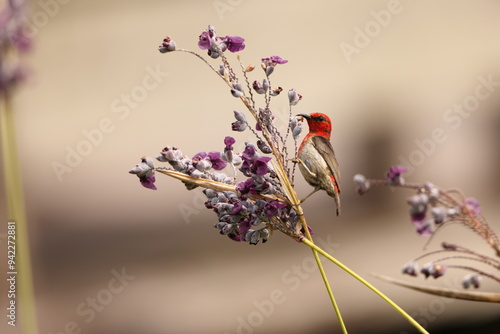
0,0,500,334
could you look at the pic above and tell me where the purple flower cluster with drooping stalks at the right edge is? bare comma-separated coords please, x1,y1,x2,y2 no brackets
354,166,500,288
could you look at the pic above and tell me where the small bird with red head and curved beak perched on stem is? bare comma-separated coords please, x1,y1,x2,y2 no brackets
297,113,340,216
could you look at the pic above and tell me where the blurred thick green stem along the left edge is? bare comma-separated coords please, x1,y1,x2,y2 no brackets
0,94,38,334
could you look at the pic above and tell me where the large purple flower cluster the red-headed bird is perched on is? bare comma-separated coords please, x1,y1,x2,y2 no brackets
130,26,308,245
